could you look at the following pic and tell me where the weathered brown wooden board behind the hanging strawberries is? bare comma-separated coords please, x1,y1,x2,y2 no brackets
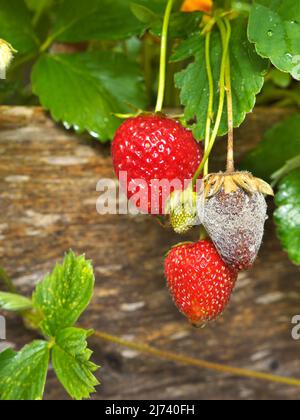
0,108,300,399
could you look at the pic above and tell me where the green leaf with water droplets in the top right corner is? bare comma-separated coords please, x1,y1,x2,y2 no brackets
248,0,300,80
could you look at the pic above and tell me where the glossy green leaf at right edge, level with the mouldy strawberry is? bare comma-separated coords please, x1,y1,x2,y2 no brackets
274,169,300,265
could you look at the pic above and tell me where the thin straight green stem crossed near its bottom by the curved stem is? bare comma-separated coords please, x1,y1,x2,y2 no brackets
204,31,214,176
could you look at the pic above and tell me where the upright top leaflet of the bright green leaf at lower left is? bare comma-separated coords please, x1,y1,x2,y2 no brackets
33,252,95,336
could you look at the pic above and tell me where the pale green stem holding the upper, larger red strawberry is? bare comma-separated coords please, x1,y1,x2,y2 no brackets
155,0,174,112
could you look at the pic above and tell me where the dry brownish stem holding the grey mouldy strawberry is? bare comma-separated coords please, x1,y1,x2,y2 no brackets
225,18,234,172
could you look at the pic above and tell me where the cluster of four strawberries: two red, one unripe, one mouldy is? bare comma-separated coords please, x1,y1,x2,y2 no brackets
112,115,272,326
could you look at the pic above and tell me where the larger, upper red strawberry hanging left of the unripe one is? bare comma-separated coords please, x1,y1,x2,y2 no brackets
112,115,203,215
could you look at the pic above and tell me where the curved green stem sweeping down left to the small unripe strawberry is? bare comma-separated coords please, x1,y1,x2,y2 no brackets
193,20,231,186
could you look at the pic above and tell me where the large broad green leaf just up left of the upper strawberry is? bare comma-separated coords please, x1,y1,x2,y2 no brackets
32,51,147,141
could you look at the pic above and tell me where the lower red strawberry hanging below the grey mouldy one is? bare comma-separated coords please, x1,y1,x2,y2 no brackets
165,240,237,325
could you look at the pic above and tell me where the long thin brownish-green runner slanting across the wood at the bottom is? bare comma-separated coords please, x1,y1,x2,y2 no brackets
94,331,300,388
